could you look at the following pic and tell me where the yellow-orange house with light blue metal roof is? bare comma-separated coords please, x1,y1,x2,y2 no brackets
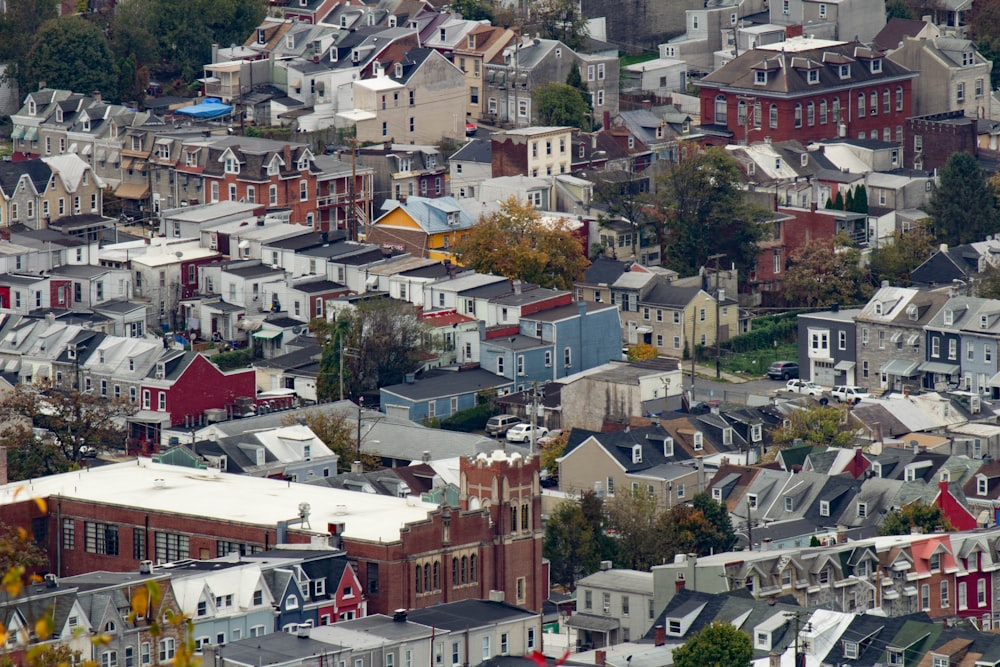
367,196,476,262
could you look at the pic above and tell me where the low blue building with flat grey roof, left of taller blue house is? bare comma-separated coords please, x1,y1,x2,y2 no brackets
379,367,514,421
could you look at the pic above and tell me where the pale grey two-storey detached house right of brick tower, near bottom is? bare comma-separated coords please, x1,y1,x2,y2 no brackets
566,569,656,648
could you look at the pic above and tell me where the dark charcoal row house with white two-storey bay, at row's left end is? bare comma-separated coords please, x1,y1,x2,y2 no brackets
797,307,861,387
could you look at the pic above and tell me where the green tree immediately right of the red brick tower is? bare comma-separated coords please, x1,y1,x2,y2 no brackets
542,500,598,590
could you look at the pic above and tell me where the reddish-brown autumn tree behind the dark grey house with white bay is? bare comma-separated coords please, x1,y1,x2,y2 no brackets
782,237,871,308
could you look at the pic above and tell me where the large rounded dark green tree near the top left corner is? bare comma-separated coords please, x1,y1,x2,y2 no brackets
20,16,119,99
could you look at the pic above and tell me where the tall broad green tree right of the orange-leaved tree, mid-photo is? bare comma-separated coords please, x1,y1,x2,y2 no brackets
651,148,766,280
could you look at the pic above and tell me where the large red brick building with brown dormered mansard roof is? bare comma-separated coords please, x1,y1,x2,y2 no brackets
698,37,917,144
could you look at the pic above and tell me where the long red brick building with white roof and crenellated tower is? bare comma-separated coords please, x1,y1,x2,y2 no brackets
0,453,548,613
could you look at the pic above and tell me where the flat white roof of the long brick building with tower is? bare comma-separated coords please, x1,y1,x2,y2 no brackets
0,458,437,542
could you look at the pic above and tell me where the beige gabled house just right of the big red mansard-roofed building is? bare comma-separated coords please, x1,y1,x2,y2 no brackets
886,36,993,118
